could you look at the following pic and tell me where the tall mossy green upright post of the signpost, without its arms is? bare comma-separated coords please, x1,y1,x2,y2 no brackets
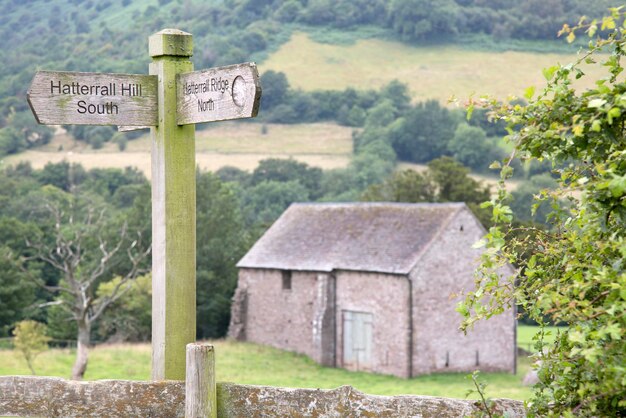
149,29,196,380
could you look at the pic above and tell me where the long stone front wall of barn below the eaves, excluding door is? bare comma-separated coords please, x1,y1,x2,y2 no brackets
230,269,410,377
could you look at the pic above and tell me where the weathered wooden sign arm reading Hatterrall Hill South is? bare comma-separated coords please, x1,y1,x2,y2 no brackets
27,71,157,126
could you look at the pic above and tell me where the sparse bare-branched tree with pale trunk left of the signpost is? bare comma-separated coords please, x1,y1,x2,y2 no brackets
20,195,150,380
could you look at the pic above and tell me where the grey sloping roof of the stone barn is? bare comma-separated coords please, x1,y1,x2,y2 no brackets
237,203,468,274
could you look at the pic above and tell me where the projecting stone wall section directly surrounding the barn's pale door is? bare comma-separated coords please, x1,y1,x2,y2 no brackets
335,271,410,377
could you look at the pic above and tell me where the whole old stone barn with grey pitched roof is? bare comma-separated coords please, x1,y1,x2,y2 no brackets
229,203,516,377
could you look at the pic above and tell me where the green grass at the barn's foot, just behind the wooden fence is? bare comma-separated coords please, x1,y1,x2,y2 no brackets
0,326,535,399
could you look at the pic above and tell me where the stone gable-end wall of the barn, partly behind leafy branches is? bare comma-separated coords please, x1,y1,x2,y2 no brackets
411,210,516,375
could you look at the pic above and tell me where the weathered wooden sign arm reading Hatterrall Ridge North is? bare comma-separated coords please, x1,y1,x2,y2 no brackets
176,62,261,125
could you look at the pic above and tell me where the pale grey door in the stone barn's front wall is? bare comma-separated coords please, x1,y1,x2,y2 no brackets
343,311,373,371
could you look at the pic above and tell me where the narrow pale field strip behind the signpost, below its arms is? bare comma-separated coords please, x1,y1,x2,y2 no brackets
0,122,352,178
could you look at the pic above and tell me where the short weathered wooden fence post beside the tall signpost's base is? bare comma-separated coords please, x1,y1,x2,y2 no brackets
185,344,217,418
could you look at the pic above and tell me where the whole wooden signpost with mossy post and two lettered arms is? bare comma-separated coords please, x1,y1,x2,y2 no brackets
28,29,261,380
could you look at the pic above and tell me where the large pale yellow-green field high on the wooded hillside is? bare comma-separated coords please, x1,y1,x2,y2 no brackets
259,32,599,103
